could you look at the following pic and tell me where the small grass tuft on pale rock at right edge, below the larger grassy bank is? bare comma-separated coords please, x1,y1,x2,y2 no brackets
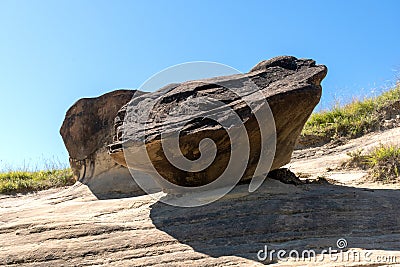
344,145,400,183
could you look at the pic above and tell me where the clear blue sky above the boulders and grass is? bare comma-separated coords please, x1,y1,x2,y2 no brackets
0,0,400,170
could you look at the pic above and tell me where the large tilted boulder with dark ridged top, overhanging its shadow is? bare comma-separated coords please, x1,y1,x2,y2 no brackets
110,56,327,186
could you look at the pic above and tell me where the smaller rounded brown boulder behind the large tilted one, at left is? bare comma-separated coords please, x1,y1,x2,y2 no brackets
60,90,142,197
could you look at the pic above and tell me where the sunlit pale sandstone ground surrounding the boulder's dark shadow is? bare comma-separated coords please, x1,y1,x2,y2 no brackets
0,128,400,266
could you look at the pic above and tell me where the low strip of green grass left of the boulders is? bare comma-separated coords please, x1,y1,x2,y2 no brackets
0,168,75,194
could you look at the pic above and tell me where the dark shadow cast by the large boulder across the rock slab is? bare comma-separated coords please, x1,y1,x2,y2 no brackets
150,179,400,261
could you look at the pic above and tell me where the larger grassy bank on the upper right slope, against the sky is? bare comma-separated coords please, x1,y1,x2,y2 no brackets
302,84,400,140
